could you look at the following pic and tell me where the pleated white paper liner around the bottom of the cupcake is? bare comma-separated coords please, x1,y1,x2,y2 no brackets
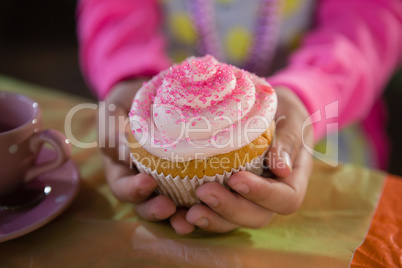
131,151,266,207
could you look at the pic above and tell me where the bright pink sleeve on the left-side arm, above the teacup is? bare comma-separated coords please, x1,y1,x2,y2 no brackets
77,0,170,99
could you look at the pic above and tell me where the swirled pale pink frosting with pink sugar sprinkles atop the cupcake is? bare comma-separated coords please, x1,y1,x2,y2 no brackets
129,55,277,162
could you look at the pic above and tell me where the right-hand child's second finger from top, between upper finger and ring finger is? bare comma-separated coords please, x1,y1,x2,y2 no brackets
197,183,273,228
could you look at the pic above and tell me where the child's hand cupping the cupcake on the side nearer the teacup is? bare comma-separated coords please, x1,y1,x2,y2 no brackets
98,79,181,226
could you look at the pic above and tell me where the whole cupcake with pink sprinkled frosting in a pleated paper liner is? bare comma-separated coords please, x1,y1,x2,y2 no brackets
128,55,277,207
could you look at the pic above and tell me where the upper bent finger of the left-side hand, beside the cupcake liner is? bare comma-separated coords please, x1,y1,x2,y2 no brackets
102,155,157,203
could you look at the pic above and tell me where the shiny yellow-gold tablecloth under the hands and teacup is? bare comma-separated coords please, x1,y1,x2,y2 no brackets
0,76,385,267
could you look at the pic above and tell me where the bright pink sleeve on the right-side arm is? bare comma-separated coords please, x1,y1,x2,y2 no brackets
268,0,402,140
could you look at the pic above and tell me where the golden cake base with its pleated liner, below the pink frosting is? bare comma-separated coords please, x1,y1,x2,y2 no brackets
127,121,275,207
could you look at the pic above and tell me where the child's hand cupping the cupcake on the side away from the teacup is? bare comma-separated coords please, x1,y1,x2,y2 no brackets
171,89,313,234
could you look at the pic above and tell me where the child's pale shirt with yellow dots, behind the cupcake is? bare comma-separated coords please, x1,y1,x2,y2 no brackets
160,0,314,75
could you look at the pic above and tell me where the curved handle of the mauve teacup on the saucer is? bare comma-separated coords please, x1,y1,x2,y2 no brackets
24,129,71,182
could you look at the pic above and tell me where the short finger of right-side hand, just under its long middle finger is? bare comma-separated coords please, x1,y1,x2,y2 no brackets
186,204,239,233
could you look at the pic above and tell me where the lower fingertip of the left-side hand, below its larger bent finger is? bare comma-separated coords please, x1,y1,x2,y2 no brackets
135,195,176,221
